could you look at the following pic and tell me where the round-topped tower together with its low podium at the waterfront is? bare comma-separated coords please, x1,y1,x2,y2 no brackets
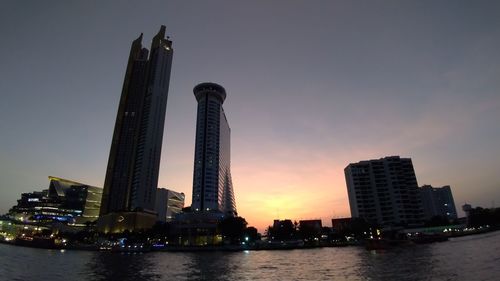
169,83,237,246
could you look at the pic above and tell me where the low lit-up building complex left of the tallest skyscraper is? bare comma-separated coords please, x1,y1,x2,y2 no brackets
9,177,102,226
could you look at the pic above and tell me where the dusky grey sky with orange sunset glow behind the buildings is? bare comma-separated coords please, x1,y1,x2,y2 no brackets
0,0,500,231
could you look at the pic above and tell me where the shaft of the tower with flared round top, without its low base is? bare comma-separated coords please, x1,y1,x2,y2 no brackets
191,83,236,216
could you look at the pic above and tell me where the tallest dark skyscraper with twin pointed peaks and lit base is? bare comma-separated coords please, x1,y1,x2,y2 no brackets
98,26,173,232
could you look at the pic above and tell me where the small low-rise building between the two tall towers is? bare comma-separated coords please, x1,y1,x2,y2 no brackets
155,188,185,222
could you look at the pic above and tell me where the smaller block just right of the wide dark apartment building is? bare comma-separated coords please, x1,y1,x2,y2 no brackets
420,185,457,221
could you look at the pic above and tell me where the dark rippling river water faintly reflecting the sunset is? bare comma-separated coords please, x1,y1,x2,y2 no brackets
0,232,500,281
